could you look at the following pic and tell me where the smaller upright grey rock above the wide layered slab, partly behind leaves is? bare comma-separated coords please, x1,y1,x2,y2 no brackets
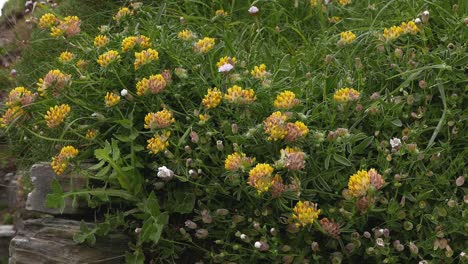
26,162,86,215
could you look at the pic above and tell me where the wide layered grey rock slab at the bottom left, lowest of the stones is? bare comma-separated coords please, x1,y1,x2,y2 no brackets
9,218,128,264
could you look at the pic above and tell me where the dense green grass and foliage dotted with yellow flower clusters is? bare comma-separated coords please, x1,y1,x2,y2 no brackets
3,0,468,263
